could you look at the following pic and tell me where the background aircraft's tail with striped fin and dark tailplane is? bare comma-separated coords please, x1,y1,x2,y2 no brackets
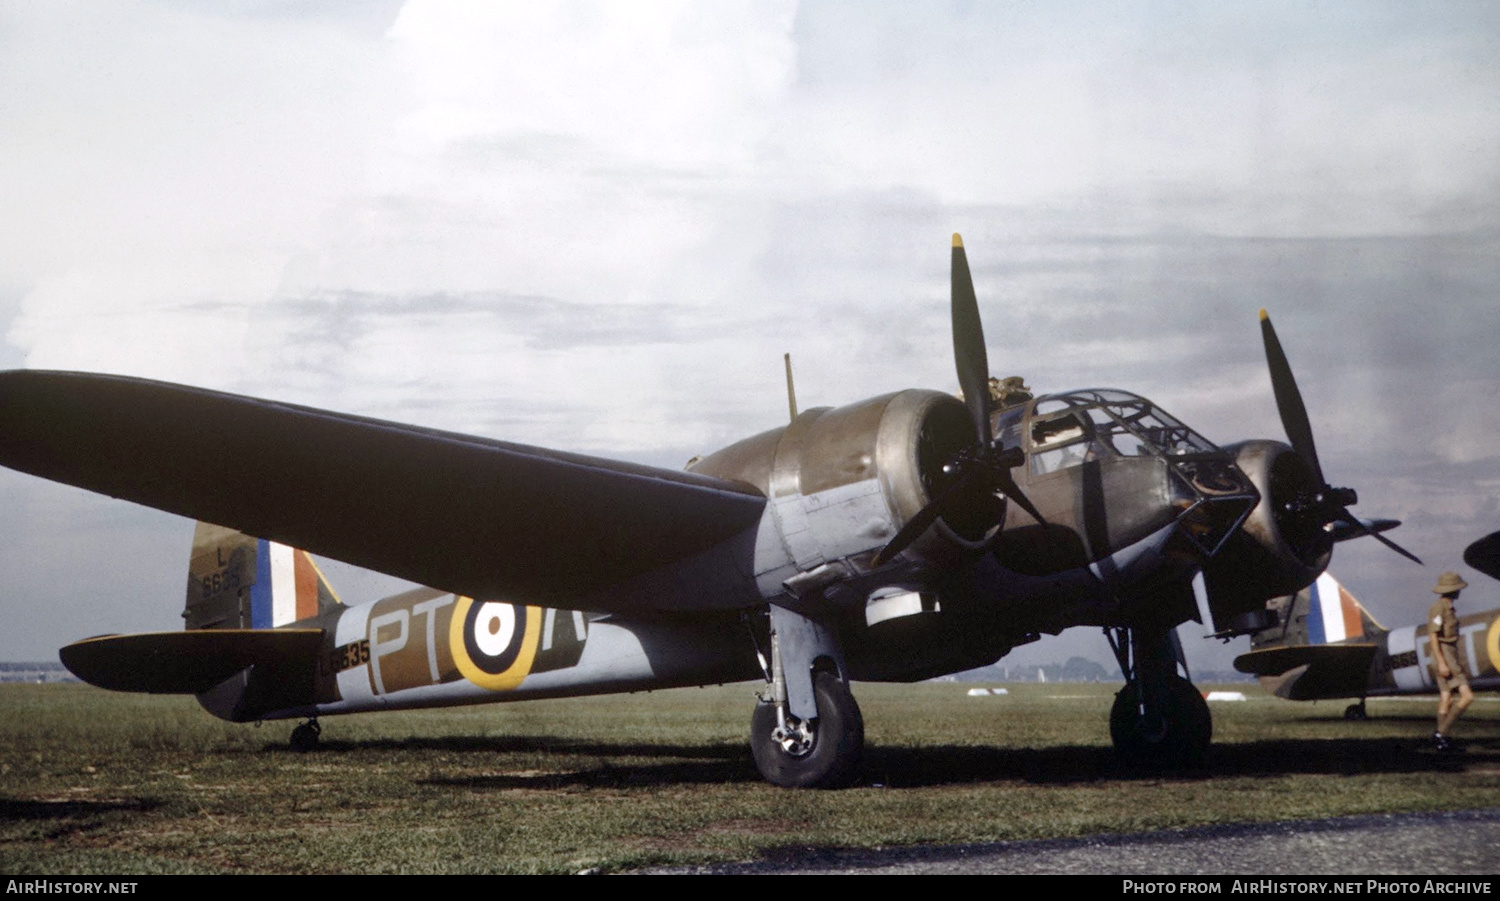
1235,573,1389,700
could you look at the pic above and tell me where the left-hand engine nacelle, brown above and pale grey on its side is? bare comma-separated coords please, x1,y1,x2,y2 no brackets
689,390,998,590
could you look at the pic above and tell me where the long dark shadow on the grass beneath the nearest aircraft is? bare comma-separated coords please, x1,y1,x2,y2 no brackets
279,736,1500,790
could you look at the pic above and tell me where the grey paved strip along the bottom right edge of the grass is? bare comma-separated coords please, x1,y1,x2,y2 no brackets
645,808,1500,877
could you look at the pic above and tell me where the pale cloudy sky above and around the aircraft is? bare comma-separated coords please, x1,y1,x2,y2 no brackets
0,0,1500,680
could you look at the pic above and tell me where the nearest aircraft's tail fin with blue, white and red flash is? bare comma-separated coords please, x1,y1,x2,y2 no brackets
183,522,342,630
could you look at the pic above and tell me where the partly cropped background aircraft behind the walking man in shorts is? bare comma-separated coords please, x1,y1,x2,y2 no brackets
1235,532,1500,720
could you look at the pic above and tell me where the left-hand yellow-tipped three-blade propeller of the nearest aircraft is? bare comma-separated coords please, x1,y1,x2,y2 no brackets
875,234,1046,565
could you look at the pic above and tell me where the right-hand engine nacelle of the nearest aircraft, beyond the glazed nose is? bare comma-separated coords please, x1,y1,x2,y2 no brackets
1203,439,1334,634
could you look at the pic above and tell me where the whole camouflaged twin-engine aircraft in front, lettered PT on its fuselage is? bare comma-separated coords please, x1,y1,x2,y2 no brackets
0,235,1415,786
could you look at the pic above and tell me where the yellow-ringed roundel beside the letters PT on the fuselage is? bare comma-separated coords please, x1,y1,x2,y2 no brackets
449,598,542,691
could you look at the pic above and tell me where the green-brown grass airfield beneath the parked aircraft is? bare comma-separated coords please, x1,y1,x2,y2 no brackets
0,684,1500,876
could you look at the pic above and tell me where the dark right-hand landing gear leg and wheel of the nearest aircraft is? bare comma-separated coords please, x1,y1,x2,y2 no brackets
1106,627,1214,769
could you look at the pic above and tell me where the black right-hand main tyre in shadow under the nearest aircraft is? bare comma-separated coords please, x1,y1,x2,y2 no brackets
1110,676,1214,769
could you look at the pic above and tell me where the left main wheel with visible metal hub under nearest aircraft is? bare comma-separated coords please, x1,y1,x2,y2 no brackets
750,673,864,789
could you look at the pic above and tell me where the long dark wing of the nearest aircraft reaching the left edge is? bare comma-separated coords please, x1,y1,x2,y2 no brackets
0,370,767,612
